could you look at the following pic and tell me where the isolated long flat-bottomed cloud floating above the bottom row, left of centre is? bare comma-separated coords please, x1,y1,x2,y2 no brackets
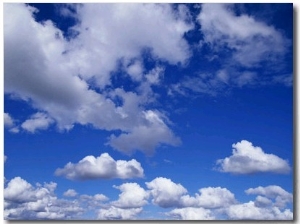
55,153,144,180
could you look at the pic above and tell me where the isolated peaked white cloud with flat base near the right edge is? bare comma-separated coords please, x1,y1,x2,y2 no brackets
217,140,291,174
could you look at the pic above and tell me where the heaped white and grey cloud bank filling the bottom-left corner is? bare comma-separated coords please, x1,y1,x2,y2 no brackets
4,177,84,220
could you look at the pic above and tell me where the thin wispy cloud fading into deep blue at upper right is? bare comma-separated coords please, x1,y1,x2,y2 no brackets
198,4,287,67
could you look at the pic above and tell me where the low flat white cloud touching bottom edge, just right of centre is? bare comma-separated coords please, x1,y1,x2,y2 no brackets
166,207,215,220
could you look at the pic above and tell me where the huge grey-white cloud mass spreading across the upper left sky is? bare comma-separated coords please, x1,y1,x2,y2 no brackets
4,4,188,153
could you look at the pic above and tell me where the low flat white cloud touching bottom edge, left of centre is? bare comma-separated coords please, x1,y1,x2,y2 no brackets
97,206,143,220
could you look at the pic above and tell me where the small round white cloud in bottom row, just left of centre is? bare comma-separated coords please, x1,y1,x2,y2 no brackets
111,183,149,208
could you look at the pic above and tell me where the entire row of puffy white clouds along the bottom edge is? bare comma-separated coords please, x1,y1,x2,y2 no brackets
4,177,293,220
